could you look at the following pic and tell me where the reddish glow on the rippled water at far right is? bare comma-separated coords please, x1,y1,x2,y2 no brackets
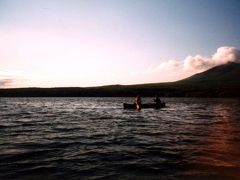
192,101,240,178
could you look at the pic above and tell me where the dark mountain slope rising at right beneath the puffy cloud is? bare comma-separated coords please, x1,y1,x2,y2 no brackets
174,62,240,97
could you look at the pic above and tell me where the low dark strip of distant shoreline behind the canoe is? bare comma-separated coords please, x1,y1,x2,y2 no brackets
0,82,240,98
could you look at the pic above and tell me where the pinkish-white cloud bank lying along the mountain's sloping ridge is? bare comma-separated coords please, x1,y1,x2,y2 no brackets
132,46,240,83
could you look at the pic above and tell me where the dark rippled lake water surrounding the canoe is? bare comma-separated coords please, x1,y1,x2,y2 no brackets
0,98,240,179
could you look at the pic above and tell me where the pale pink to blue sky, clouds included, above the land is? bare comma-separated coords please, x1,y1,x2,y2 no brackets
0,0,240,88
